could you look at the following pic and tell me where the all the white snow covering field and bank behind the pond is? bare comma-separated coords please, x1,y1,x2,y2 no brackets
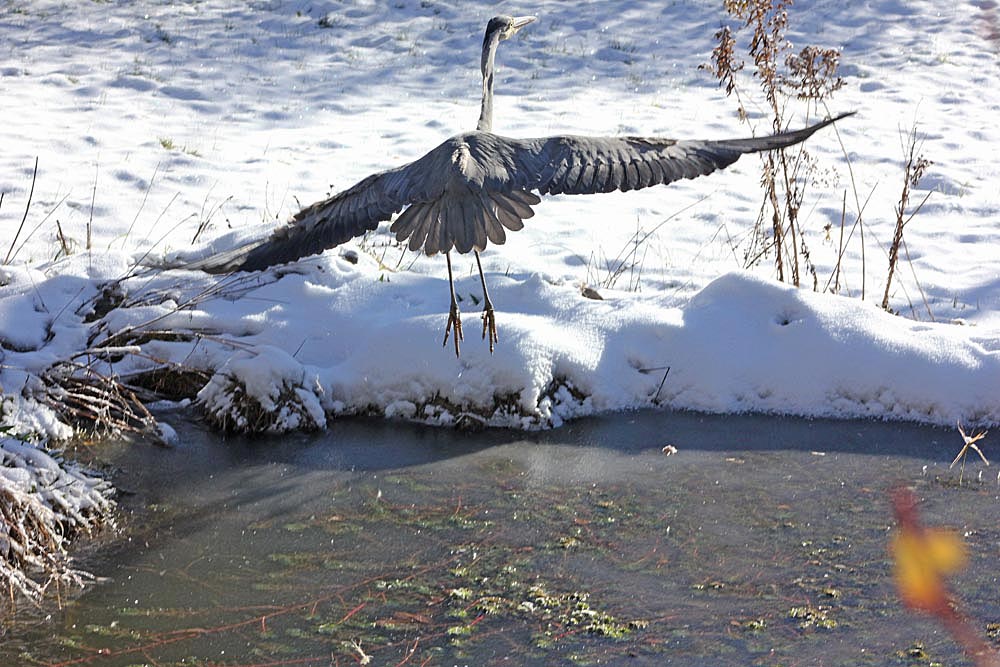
0,0,1000,592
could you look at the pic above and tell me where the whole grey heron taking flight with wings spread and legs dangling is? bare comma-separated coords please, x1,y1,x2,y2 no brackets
197,16,853,355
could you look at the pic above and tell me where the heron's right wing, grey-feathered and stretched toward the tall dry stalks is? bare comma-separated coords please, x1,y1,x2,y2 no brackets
509,112,853,195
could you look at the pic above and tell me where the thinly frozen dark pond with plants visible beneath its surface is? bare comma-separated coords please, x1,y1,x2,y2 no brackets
0,412,1000,667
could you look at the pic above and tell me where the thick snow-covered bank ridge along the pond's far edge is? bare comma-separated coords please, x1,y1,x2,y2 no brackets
8,252,1000,431
